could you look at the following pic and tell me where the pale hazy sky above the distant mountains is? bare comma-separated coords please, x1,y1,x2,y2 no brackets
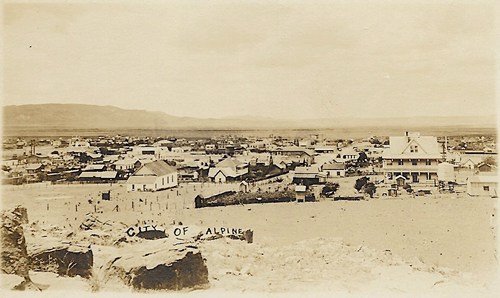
2,0,496,118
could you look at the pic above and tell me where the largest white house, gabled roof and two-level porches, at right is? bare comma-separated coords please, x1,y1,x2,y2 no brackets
382,132,442,185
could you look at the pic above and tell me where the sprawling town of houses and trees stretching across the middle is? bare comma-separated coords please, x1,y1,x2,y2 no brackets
2,132,498,196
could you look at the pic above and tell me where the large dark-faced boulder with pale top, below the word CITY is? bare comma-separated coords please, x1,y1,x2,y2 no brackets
106,239,208,290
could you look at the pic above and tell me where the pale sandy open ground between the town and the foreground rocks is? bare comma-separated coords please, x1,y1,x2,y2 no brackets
2,184,498,297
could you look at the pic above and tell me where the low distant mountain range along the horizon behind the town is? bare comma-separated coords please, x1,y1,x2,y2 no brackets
3,104,496,129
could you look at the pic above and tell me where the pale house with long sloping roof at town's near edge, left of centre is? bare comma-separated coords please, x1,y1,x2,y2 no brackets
127,160,178,191
